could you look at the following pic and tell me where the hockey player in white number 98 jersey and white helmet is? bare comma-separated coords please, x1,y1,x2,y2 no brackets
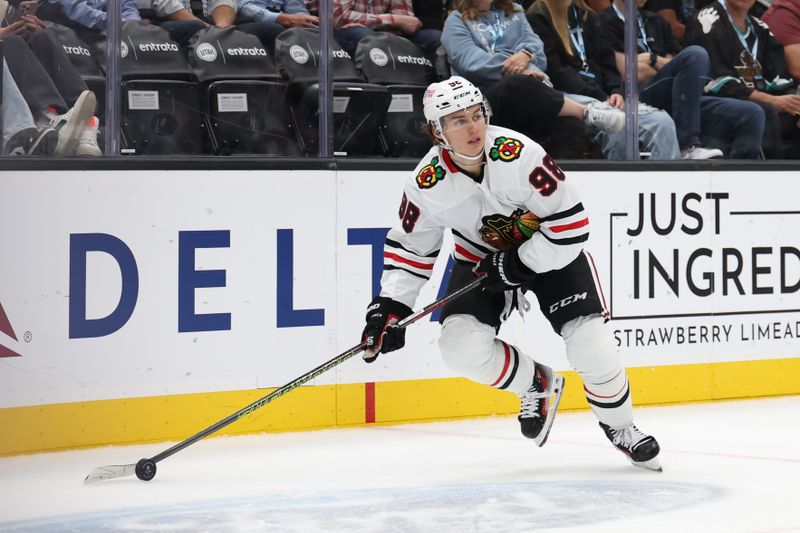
363,76,661,470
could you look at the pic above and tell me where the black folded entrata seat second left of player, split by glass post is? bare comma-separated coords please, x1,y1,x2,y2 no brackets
275,28,391,156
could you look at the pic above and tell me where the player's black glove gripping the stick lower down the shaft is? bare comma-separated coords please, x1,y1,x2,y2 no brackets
362,296,413,363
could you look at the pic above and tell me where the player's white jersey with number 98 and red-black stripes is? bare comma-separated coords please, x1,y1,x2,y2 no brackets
381,126,589,307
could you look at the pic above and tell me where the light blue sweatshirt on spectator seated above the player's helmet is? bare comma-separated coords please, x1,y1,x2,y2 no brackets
442,6,547,86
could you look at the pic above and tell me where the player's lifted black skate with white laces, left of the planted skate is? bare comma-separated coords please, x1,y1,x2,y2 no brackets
517,363,564,447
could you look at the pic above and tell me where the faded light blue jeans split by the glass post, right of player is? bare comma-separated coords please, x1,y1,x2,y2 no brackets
564,94,681,160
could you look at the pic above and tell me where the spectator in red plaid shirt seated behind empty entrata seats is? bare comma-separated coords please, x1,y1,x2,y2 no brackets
333,0,442,56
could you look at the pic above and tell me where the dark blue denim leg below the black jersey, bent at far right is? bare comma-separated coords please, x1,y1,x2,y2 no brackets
700,96,766,159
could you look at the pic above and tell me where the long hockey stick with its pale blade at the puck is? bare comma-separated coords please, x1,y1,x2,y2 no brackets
83,276,483,485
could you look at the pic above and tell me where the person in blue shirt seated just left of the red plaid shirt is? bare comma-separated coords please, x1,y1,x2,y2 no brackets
236,0,319,50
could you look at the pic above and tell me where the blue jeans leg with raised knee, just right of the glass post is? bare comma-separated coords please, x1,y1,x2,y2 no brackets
639,46,709,148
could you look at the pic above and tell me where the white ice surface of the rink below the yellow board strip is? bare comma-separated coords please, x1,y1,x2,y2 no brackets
0,396,800,533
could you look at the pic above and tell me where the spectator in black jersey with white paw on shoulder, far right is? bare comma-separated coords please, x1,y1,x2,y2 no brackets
684,0,800,158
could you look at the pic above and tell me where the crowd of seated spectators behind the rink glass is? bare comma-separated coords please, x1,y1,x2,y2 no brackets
0,0,800,160
